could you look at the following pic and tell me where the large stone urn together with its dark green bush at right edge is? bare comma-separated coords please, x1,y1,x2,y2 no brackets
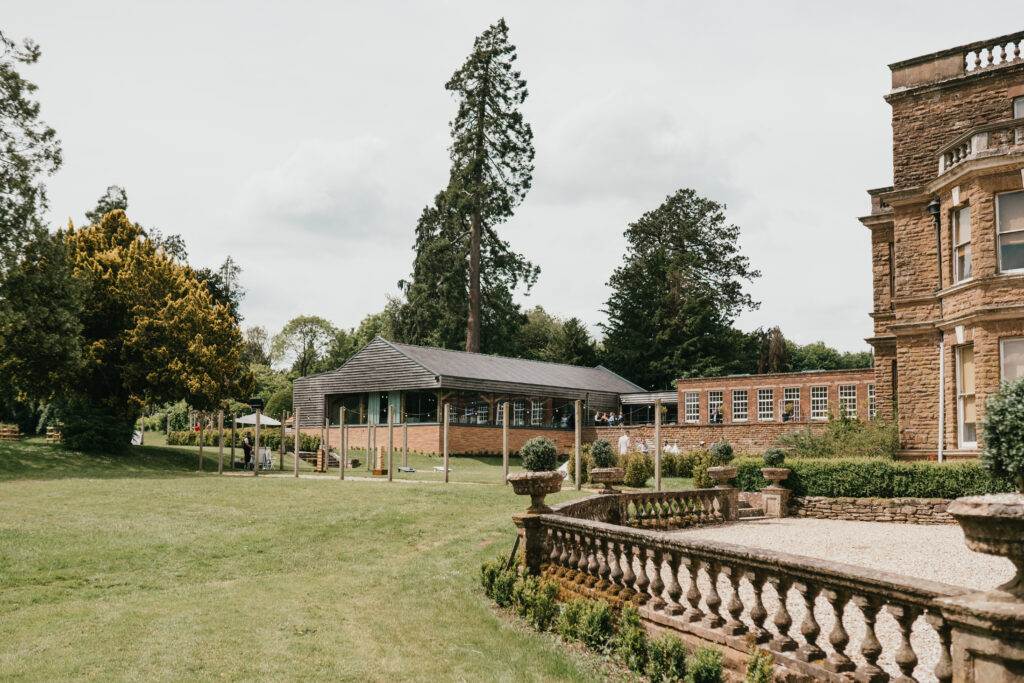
949,378,1024,600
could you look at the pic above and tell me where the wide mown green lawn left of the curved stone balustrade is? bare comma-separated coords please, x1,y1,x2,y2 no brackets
0,442,688,681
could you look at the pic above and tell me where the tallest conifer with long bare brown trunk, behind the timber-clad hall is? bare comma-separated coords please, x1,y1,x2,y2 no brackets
444,18,534,351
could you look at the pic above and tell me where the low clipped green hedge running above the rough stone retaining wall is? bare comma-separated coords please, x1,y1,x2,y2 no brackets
733,458,1015,499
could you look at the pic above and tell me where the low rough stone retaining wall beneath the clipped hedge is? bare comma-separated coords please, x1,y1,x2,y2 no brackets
790,496,956,524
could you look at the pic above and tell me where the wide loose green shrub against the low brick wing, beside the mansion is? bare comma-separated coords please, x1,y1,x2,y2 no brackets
778,416,899,460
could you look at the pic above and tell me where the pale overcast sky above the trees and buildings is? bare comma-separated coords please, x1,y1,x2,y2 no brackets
2,0,1021,350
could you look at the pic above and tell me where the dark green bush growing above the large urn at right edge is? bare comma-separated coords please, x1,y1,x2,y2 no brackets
981,378,1024,494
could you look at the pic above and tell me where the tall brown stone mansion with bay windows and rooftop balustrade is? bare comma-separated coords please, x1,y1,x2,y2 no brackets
860,33,1024,459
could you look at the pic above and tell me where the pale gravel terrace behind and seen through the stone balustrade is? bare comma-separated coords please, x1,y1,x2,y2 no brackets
673,518,1014,682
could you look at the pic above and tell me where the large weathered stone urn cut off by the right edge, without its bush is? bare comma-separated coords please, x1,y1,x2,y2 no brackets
949,493,1024,601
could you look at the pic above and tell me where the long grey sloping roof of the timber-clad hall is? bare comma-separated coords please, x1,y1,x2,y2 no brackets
381,338,644,393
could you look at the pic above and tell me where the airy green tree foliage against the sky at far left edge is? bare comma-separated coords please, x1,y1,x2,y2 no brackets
0,32,61,275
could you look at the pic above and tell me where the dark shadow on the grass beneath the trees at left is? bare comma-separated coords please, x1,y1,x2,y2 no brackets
0,440,229,481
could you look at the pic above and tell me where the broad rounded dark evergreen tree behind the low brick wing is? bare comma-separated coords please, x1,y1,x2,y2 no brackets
601,189,761,388
